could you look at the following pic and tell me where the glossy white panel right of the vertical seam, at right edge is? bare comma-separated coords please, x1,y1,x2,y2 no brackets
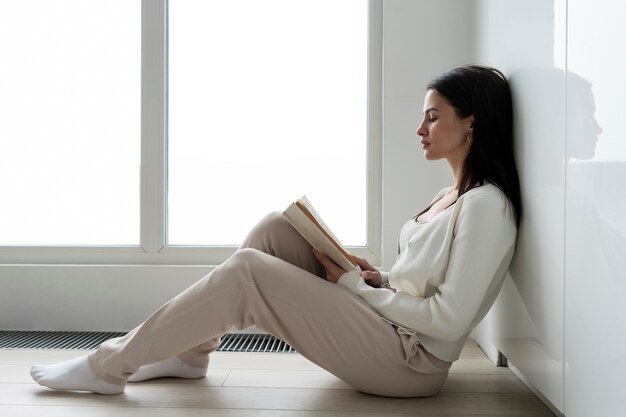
565,0,626,417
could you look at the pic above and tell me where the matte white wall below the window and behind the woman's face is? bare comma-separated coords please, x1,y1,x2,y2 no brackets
0,0,471,331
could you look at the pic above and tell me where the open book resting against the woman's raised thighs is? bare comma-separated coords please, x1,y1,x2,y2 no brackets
283,196,357,272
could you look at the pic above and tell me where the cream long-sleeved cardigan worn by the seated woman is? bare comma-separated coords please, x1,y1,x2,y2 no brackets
338,184,517,362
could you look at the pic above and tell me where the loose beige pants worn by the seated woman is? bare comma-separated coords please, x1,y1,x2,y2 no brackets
89,213,450,397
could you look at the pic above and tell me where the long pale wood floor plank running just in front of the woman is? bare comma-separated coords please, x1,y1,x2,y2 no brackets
0,383,551,417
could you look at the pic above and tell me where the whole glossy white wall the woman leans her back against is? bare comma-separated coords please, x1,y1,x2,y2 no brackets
474,0,626,417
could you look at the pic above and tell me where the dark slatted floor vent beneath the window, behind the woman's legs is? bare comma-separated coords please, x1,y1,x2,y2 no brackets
0,330,295,353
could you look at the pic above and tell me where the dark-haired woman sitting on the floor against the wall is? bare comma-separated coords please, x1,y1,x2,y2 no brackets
31,66,521,397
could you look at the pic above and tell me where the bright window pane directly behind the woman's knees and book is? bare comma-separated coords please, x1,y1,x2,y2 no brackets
168,0,368,246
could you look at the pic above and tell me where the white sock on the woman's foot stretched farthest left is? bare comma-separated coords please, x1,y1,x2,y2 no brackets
30,356,126,394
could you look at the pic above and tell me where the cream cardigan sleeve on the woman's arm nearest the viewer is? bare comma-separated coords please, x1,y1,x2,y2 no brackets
338,193,516,342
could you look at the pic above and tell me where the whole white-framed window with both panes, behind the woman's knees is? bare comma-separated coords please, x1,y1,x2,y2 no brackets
0,0,382,265
